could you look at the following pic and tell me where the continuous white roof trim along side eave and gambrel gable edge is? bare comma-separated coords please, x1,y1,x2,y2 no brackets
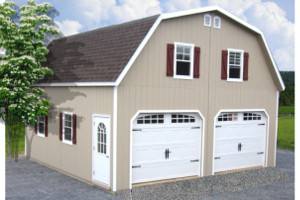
37,6,285,91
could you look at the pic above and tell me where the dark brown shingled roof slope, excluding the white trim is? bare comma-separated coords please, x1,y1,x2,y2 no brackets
42,15,158,83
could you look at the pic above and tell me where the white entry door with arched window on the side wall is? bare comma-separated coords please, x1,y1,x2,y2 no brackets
92,115,110,186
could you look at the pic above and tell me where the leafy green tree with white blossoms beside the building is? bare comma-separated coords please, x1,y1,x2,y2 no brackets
0,0,59,160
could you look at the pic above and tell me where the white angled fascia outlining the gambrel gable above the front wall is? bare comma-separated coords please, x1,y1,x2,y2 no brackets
116,6,285,90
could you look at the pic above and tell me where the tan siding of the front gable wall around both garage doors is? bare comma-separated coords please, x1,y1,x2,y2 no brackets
117,11,277,189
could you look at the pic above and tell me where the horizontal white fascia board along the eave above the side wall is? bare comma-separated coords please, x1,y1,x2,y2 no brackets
35,82,116,87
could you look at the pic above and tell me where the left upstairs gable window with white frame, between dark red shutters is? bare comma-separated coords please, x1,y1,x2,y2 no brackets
174,43,194,79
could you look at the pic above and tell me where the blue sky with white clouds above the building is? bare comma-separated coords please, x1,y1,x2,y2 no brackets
15,0,295,70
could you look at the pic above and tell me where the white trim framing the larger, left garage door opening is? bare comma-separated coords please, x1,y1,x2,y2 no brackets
129,110,206,189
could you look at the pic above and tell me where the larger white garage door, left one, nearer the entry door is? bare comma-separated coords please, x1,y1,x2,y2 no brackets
132,113,202,183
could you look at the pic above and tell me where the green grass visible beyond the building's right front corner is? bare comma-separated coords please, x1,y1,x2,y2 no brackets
277,106,295,150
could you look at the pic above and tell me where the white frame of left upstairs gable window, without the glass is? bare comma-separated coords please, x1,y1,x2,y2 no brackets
173,42,195,79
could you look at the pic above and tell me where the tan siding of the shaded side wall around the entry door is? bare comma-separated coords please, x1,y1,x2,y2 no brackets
27,87,113,185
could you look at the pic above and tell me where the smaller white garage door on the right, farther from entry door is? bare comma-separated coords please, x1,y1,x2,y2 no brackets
214,112,267,172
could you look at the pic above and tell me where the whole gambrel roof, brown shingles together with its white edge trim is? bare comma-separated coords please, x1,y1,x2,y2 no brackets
39,6,285,91
